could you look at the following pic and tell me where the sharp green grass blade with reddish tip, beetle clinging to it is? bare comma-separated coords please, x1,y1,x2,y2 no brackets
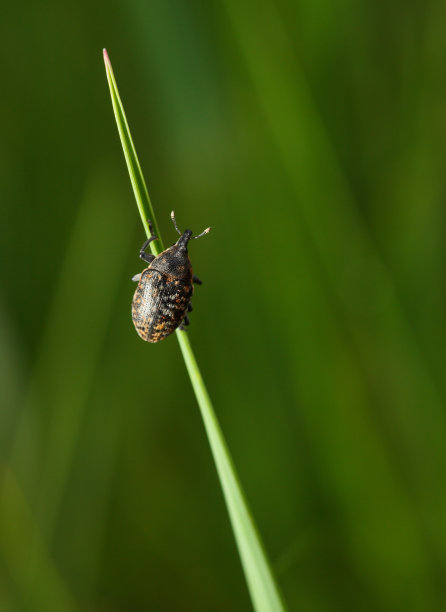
104,49,284,612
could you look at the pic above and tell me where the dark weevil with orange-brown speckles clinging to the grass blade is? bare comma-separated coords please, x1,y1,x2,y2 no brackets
132,211,211,342
